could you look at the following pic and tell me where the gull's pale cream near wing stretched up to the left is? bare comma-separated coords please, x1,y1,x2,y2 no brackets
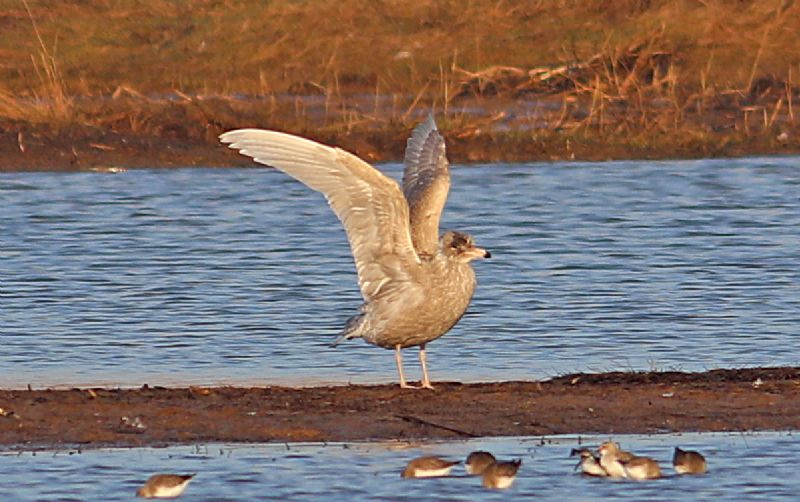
220,129,419,301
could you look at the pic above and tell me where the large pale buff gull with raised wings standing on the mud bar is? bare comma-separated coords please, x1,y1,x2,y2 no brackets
220,116,491,389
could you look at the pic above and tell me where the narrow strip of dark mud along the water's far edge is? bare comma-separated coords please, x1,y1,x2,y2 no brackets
0,128,800,173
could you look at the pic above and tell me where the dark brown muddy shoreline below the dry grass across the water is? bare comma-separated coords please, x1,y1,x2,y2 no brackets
0,115,800,172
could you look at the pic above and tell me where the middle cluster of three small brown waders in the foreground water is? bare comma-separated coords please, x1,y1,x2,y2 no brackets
402,451,522,490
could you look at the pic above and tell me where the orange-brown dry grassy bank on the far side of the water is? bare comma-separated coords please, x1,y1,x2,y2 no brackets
0,0,800,170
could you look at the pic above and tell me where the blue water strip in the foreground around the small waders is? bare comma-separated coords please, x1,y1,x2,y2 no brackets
0,433,800,502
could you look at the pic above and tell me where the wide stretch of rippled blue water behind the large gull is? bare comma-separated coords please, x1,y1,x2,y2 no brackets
0,157,800,386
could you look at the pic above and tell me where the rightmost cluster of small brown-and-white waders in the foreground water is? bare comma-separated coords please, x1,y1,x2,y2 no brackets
572,441,708,480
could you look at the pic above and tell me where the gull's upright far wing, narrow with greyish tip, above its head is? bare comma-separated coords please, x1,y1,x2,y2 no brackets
403,115,450,255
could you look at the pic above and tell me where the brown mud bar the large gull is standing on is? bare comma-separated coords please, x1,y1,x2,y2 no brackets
0,367,800,450
